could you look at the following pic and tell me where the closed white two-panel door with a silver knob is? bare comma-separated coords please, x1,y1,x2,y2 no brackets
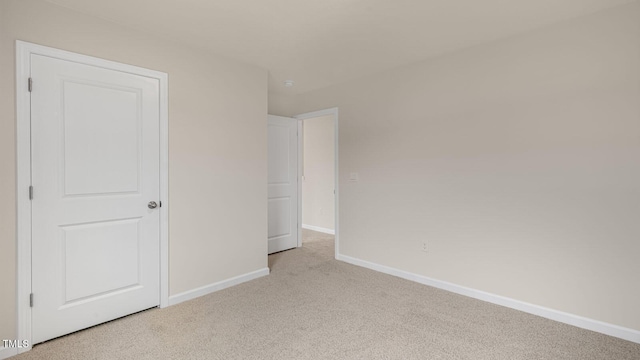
31,55,160,343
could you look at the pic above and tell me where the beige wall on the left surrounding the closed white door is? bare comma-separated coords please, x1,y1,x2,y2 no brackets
0,0,267,339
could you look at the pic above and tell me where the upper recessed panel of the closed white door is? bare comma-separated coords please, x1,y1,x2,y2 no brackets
62,79,141,195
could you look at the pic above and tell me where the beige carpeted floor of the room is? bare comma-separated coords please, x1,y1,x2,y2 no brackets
12,230,640,360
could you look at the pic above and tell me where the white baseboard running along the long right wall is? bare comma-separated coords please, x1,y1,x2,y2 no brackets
337,254,640,343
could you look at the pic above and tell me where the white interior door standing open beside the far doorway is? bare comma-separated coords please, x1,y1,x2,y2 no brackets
267,115,298,254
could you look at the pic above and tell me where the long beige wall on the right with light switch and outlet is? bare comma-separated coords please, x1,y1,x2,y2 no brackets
296,2,640,330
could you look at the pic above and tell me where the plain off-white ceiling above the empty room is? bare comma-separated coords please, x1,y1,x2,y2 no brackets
47,0,633,94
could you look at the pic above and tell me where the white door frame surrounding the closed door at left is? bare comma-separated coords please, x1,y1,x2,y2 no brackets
16,40,169,353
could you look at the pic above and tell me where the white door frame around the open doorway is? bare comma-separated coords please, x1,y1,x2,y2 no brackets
294,107,340,259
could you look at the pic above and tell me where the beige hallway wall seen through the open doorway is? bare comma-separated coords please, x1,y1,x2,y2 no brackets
302,115,335,230
